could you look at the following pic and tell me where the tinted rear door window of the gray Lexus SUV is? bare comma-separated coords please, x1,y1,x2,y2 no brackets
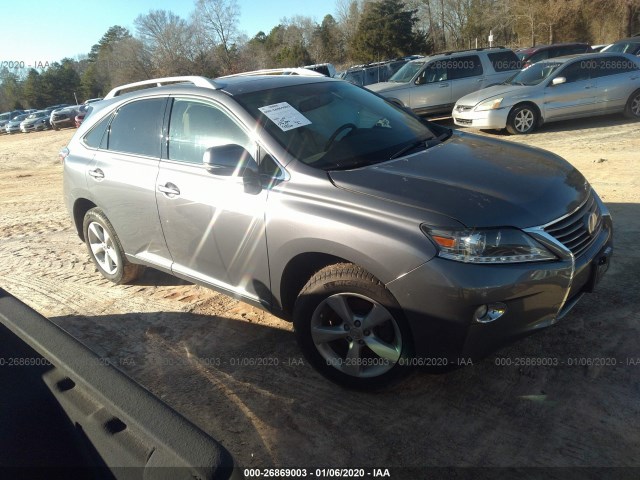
107,98,166,157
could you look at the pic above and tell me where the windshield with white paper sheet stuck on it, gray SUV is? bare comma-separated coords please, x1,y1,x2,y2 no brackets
236,81,435,170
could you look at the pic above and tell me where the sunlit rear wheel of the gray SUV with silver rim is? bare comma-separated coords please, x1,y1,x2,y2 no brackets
82,208,144,285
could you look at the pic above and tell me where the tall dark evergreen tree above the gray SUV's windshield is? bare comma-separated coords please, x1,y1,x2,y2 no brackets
352,0,427,61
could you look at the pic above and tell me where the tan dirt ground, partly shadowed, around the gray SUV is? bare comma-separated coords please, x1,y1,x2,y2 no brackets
0,116,640,472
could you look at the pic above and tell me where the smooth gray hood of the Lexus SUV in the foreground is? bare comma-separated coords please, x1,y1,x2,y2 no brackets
329,133,590,228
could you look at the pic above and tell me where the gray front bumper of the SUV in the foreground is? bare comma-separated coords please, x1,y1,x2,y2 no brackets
387,215,613,365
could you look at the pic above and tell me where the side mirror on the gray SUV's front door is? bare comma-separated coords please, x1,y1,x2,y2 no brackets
202,144,262,193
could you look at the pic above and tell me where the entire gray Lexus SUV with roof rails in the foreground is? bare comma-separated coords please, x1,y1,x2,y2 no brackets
61,75,612,388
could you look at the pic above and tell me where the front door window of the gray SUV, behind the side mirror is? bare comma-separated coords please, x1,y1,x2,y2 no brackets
168,98,255,164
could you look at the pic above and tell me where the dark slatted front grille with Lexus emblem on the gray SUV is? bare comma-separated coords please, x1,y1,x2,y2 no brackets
544,194,602,258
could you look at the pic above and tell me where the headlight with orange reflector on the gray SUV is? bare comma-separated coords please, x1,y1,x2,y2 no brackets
421,225,557,263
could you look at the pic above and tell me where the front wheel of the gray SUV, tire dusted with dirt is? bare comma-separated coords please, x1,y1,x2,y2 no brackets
293,263,412,390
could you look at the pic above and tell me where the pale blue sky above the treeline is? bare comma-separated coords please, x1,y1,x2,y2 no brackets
0,0,336,68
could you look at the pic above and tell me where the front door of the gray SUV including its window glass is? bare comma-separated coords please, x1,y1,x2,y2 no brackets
156,97,270,304
